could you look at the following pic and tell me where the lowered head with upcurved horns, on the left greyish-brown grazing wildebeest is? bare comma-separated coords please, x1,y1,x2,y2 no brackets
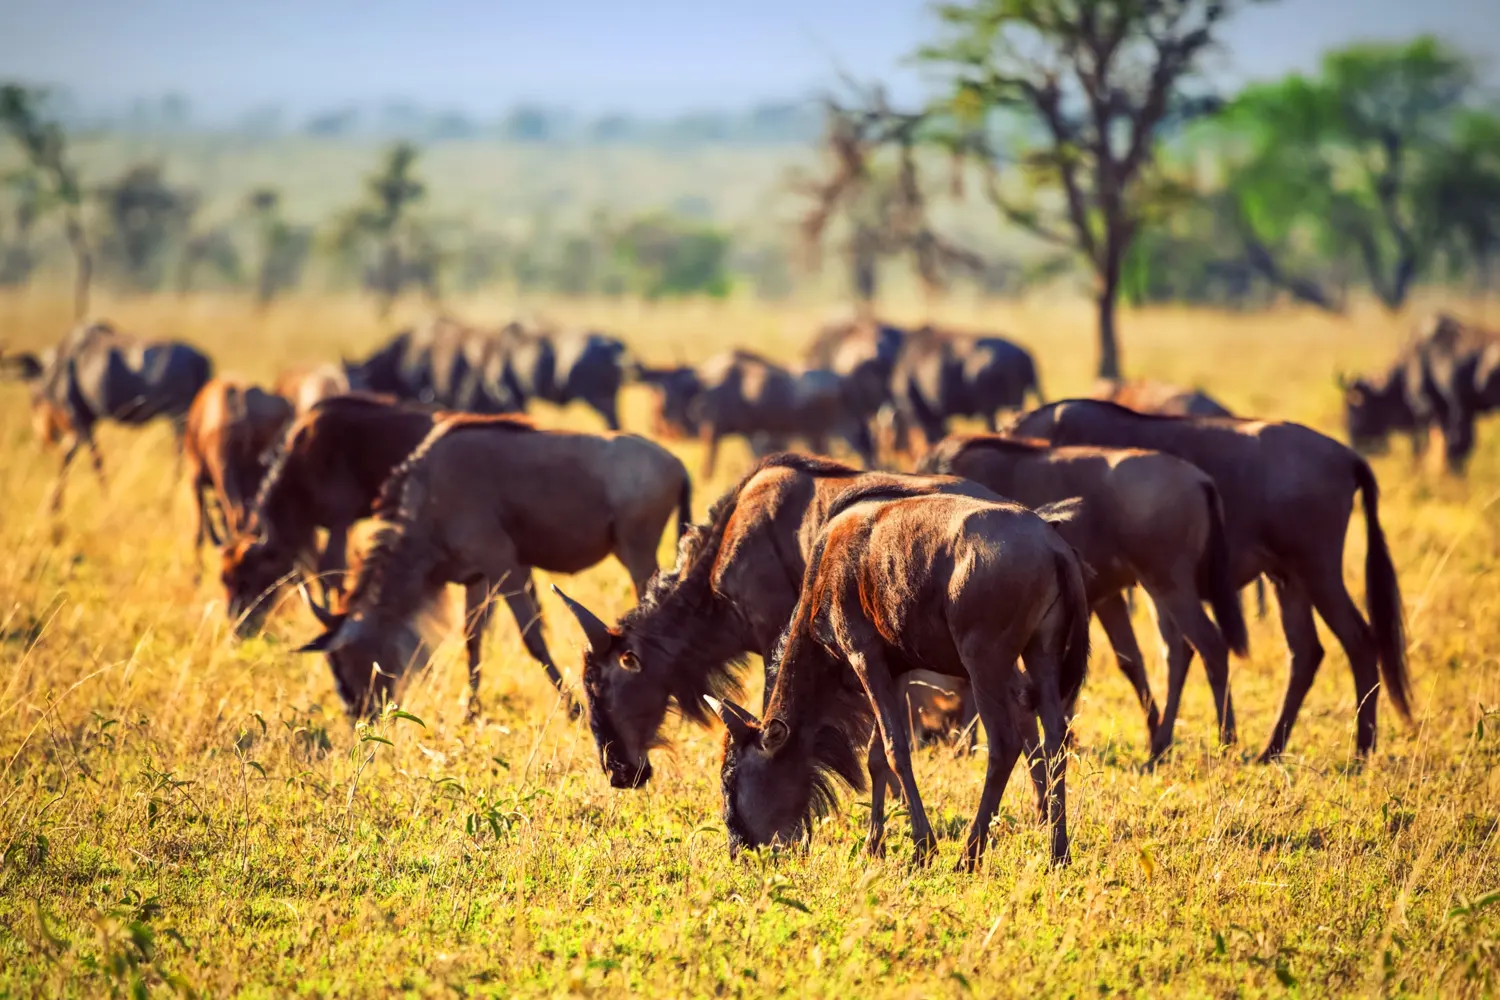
297,588,431,718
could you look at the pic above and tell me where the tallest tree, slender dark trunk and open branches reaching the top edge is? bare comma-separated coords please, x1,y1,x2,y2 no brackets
920,0,1260,378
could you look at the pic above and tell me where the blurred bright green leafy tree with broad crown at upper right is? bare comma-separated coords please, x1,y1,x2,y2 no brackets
1217,37,1500,310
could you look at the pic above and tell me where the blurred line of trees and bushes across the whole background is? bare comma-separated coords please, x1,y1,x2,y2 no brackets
0,25,1500,334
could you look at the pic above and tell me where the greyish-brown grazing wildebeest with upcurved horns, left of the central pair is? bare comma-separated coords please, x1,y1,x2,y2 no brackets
295,415,692,715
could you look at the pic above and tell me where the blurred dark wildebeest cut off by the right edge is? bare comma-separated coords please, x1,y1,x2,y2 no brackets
1340,313,1500,474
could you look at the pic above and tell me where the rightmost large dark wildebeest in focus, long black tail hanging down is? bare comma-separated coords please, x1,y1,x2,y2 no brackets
1016,399,1412,762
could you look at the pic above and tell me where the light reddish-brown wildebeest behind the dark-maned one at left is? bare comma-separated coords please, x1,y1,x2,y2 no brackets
183,376,293,571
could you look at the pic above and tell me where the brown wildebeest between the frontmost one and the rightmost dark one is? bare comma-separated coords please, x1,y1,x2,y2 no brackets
918,435,1248,760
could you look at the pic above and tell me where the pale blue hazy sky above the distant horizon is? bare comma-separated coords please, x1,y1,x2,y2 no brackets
0,0,1500,114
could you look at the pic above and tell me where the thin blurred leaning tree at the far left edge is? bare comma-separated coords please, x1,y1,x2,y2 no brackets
0,84,93,319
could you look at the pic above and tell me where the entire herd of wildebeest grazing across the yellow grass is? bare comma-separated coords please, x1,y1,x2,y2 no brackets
0,313,1500,868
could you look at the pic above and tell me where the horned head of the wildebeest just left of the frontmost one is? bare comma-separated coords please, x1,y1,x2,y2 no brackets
552,585,672,789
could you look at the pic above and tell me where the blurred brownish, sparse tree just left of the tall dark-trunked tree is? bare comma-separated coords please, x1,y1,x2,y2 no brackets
791,87,984,310
